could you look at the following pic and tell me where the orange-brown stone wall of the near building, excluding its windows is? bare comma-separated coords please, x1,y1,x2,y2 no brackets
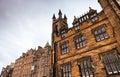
52,0,120,77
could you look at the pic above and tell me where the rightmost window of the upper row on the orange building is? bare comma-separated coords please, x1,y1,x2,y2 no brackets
92,24,109,42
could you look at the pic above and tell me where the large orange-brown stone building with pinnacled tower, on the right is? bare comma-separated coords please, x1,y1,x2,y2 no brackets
51,0,120,77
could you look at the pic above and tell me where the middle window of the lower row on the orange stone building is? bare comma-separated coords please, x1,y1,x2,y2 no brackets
78,56,94,77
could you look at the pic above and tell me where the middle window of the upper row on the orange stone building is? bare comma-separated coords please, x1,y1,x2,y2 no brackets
74,34,86,49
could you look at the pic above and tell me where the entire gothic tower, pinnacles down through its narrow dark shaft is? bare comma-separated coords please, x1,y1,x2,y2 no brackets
52,10,68,77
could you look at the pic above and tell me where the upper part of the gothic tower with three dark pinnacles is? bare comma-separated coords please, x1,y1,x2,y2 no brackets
52,10,68,41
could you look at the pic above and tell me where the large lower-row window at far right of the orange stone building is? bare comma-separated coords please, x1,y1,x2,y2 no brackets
100,48,120,76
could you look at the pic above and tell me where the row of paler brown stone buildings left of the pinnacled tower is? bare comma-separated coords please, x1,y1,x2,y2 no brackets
12,43,51,77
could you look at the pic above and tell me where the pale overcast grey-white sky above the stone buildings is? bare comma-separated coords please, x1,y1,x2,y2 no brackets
0,0,101,71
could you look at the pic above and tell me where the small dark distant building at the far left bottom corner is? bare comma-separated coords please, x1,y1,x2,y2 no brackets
0,63,14,77
